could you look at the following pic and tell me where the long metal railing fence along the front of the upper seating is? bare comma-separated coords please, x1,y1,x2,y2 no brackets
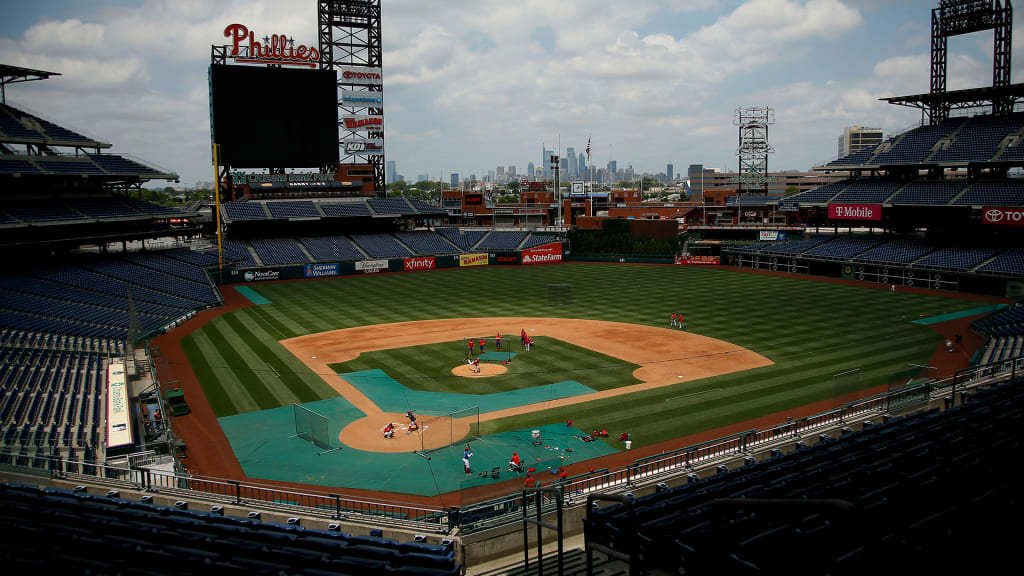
0,357,1024,533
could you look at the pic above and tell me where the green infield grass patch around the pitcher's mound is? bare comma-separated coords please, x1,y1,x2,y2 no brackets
331,336,640,395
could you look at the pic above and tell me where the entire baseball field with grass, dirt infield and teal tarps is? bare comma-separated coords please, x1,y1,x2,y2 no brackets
161,263,984,496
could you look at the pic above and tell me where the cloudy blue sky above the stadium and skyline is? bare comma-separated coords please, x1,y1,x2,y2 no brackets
0,0,1024,187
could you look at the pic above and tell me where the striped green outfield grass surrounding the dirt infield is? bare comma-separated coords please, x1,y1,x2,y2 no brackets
183,264,977,446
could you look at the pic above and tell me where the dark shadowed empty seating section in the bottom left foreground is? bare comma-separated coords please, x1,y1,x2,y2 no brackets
0,484,462,576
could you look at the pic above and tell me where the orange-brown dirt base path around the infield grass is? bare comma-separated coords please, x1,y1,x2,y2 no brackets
281,318,773,452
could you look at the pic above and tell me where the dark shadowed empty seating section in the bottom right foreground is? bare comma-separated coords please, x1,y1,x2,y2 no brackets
584,384,1024,574
